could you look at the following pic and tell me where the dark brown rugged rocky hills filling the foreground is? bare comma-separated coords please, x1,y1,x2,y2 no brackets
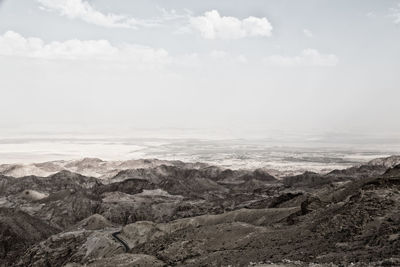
0,156,400,267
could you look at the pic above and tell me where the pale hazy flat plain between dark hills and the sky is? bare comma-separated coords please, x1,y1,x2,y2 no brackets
0,138,400,177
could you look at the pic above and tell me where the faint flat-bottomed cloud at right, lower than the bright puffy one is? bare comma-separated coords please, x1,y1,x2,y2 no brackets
264,49,339,67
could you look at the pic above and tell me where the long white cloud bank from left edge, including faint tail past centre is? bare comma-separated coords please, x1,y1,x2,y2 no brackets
0,31,247,71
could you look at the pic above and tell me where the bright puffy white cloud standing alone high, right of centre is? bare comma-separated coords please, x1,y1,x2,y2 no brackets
190,10,272,40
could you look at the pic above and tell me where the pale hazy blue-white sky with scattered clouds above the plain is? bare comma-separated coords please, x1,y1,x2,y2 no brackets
0,0,400,141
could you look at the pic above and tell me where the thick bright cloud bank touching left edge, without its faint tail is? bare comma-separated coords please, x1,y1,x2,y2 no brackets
0,31,170,67
